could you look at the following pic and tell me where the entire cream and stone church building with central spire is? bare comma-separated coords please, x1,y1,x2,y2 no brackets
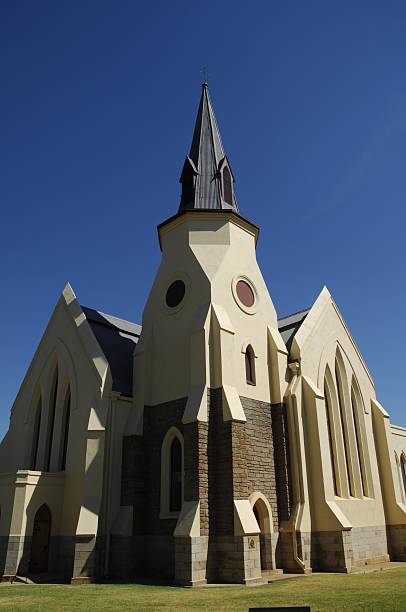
0,83,406,586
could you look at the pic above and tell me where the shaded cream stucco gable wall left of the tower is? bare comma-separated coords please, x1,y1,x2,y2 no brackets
0,285,111,535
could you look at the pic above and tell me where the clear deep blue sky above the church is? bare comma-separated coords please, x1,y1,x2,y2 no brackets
0,0,406,436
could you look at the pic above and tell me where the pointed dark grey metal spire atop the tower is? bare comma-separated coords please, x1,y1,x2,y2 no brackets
179,83,238,212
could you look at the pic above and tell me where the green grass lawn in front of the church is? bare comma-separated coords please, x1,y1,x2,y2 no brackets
0,569,406,612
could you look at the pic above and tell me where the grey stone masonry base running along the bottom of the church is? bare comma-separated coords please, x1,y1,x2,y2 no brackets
0,525,406,586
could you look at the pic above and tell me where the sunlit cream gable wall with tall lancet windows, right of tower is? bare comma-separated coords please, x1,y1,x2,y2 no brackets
291,288,385,531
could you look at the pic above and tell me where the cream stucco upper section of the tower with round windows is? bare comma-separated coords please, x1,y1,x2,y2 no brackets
129,212,287,438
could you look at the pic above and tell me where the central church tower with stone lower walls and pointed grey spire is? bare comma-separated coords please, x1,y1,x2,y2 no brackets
122,83,289,585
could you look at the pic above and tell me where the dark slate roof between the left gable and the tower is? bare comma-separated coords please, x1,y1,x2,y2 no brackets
82,306,141,395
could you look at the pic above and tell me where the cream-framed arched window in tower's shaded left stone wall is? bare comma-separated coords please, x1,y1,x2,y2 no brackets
160,427,184,518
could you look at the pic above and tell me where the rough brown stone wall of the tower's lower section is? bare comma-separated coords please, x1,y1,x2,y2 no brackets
114,389,288,584
